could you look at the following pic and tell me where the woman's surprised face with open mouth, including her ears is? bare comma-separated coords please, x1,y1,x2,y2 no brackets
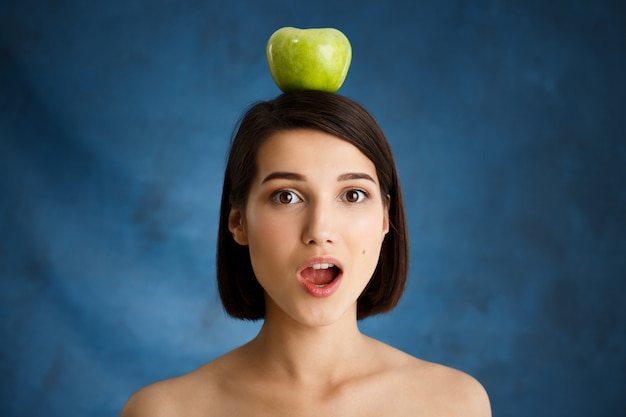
229,129,389,326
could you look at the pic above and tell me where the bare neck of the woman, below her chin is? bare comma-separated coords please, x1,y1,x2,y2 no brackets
244,300,369,384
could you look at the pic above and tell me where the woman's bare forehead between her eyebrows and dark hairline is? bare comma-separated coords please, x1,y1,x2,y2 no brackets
257,129,376,177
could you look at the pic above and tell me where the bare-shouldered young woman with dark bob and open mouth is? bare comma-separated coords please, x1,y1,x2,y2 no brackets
122,91,491,417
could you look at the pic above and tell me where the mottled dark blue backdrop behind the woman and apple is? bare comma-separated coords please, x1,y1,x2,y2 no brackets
0,0,626,417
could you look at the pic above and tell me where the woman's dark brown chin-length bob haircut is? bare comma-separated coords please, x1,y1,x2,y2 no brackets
217,90,408,320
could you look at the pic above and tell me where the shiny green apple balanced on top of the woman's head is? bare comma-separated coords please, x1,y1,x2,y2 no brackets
266,27,352,93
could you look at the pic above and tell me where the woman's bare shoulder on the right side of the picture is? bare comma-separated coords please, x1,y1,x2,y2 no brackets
370,342,491,417
